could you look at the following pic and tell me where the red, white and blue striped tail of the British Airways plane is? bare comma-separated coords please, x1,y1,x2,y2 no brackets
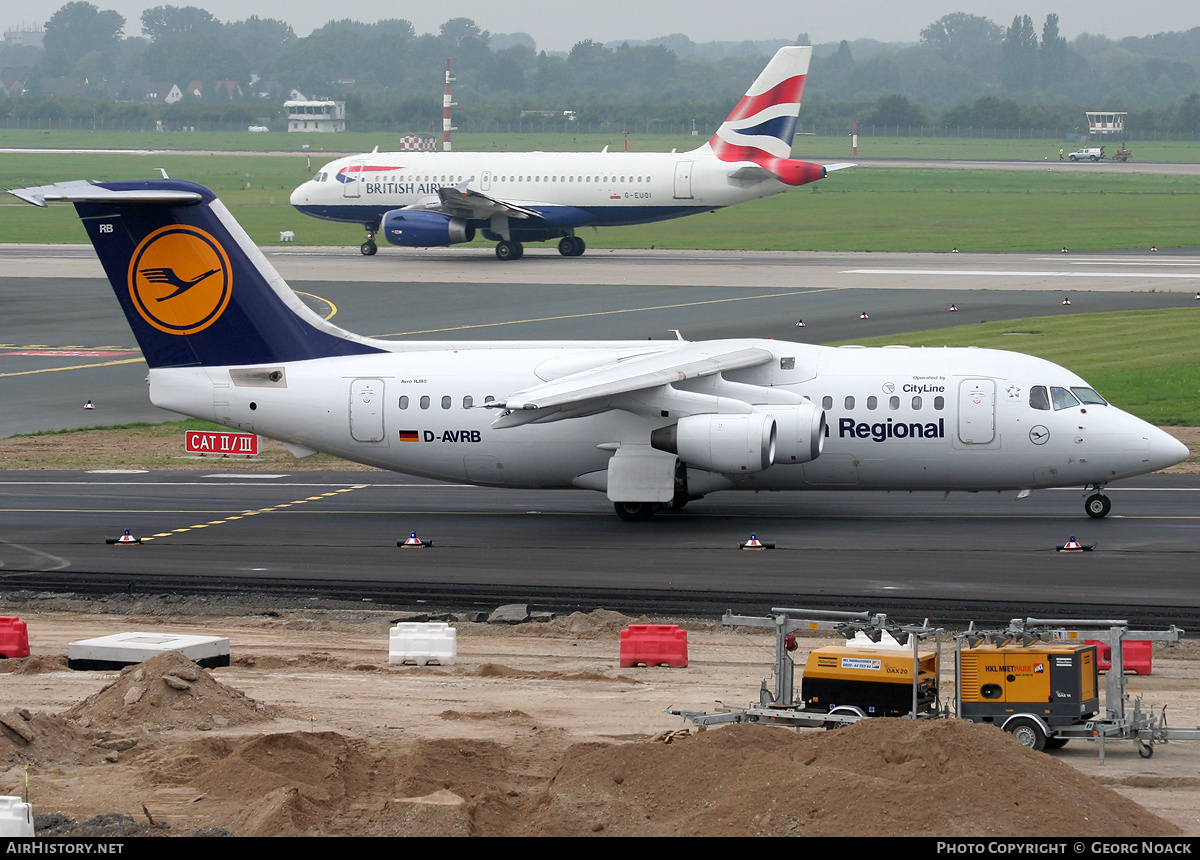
708,46,824,185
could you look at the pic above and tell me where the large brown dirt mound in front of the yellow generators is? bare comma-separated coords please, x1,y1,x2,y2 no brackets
524,720,1180,836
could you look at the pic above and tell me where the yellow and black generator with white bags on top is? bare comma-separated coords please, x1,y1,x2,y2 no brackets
800,632,937,717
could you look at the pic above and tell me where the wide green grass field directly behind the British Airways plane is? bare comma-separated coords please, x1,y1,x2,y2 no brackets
0,145,1200,252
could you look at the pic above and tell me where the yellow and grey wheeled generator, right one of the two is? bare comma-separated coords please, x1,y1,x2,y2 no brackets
956,642,1100,750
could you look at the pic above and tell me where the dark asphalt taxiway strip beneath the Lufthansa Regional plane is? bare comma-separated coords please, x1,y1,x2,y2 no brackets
0,471,1200,626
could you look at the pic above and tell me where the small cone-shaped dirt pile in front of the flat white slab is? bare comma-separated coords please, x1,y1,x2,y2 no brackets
65,651,275,730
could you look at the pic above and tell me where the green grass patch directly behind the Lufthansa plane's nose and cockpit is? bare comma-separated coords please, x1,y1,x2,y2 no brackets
835,308,1200,427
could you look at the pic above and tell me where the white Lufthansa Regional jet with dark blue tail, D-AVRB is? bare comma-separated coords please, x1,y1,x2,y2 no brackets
12,179,1188,519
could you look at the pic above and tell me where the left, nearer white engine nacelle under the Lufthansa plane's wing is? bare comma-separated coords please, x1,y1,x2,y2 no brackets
650,413,776,474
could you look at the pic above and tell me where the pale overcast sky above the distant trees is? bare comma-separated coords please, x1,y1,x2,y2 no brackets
9,0,1200,50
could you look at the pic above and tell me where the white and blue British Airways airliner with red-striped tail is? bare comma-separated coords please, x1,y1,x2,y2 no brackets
292,47,853,260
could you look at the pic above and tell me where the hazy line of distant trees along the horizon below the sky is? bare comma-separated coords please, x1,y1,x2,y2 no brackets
7,0,1200,133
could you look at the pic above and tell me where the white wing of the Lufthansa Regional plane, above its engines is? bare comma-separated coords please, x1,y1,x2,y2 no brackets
488,342,774,429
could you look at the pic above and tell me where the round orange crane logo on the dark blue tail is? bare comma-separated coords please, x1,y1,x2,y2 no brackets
130,224,233,335
